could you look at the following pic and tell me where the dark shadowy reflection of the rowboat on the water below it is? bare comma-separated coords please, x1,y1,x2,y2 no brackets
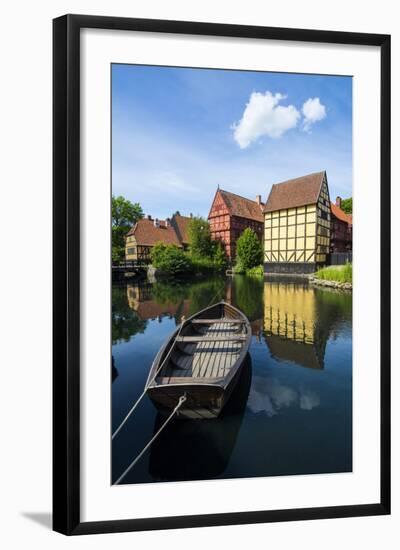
149,356,251,481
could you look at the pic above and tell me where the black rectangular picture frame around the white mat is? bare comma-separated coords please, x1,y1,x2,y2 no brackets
53,15,390,535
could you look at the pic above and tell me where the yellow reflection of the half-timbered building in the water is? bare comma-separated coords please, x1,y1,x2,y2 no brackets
264,282,329,369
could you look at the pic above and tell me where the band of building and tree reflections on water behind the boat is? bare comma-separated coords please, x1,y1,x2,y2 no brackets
122,276,351,369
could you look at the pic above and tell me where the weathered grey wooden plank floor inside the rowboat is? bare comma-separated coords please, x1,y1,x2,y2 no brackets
163,321,244,383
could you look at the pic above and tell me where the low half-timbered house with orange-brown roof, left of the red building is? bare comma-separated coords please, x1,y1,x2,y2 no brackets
125,215,190,262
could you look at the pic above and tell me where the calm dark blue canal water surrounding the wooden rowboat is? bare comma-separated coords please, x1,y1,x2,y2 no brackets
112,276,352,483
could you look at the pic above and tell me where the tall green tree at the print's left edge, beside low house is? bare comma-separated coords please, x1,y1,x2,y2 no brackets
111,195,144,261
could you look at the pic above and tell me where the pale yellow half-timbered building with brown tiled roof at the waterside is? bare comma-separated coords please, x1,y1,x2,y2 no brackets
264,172,331,273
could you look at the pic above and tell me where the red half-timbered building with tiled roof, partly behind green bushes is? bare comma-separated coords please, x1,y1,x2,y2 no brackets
208,188,264,260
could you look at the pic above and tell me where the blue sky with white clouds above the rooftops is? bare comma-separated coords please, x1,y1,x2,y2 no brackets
112,65,352,219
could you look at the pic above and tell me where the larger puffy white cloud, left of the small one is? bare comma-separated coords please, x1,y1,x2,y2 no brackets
232,91,300,149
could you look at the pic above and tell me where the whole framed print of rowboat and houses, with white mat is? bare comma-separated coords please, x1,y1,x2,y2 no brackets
53,15,390,535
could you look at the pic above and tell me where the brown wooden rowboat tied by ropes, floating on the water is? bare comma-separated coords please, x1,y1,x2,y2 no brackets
146,302,251,419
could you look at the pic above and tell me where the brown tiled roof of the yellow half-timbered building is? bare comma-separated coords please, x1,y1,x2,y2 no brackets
264,172,325,212
